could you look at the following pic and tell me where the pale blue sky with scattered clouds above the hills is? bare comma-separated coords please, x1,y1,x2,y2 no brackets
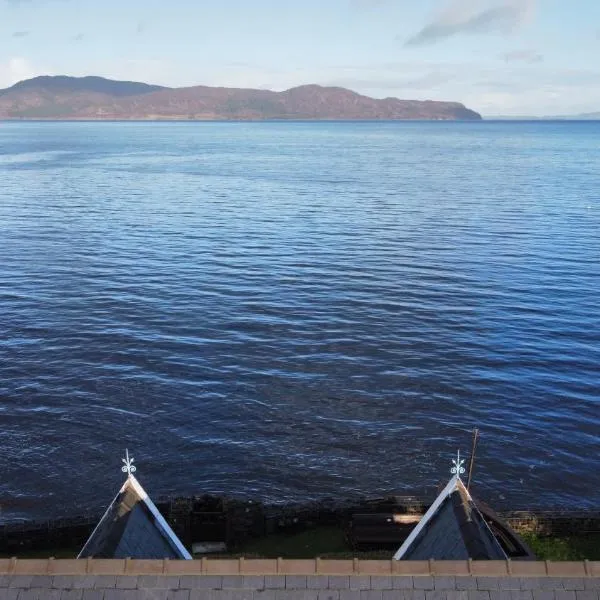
0,0,600,116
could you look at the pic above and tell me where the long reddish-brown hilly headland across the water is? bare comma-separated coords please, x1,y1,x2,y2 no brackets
0,76,481,120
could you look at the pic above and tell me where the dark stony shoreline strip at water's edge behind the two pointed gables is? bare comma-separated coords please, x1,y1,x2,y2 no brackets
0,496,600,555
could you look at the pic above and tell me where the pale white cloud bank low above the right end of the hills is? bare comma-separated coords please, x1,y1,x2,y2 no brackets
306,61,600,116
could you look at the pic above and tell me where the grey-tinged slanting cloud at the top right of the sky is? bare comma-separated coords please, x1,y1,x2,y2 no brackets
405,0,536,46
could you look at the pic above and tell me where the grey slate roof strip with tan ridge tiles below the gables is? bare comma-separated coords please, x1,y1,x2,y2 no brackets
0,559,600,600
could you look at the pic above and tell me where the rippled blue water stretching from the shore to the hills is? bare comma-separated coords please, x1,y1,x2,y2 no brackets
0,122,600,520
